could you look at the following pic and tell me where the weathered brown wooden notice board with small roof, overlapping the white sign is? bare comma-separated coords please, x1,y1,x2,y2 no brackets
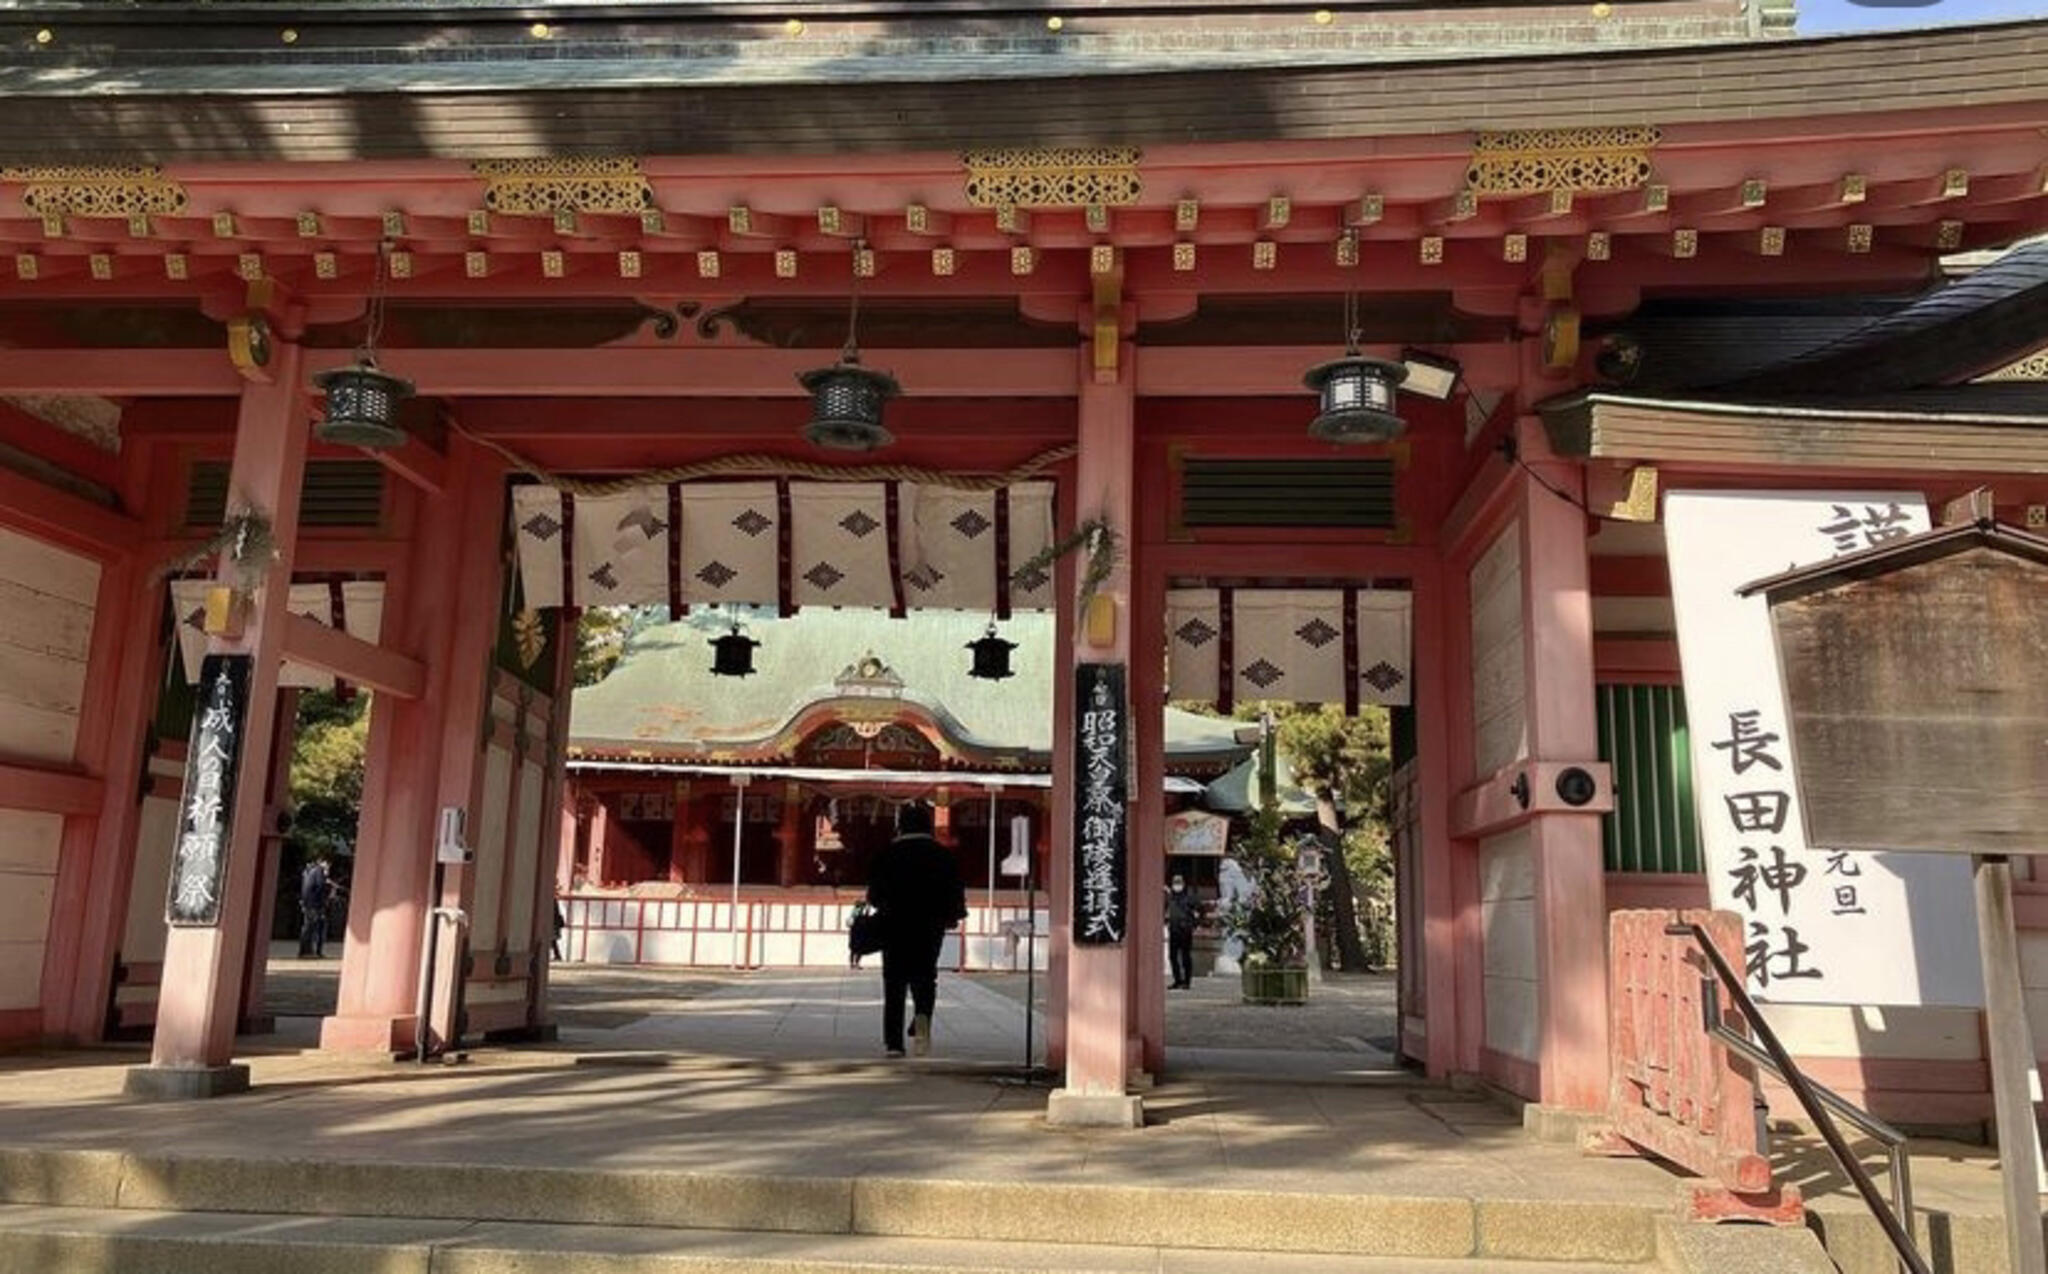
1755,526,2048,854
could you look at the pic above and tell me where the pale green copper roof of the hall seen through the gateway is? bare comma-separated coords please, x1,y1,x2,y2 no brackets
569,608,1245,768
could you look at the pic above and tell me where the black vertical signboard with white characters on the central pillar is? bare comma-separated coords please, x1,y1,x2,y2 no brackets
1073,664,1130,946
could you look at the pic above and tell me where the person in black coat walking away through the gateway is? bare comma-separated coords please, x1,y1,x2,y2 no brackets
868,801,967,1057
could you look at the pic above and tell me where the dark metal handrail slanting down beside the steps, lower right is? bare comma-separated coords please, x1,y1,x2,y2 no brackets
1665,922,1933,1274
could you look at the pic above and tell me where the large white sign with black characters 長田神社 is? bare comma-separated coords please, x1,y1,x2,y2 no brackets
1665,492,1982,1006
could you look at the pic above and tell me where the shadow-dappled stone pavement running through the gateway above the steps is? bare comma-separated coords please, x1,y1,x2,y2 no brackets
0,969,2031,1274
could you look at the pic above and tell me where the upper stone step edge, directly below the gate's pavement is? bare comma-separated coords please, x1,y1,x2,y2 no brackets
0,1147,1663,1264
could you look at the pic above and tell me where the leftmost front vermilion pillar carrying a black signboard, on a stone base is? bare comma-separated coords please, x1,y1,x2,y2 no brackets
127,342,311,1096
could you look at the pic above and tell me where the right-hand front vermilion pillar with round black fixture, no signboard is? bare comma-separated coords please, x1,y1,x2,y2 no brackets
1520,426,1608,1110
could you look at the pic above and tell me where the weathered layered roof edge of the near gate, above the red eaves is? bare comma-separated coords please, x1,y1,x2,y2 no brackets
0,18,2048,164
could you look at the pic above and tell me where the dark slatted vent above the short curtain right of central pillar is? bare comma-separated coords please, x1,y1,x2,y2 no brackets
1180,459,1395,530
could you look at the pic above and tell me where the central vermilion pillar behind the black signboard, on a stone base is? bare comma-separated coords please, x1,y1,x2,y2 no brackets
1047,344,1153,1127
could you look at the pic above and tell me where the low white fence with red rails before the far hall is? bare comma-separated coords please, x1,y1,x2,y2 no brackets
561,893,1051,971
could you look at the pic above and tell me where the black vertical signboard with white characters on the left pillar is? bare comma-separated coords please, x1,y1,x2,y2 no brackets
164,655,250,928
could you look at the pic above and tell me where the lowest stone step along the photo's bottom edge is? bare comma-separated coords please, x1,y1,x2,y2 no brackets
0,1204,1657,1274
